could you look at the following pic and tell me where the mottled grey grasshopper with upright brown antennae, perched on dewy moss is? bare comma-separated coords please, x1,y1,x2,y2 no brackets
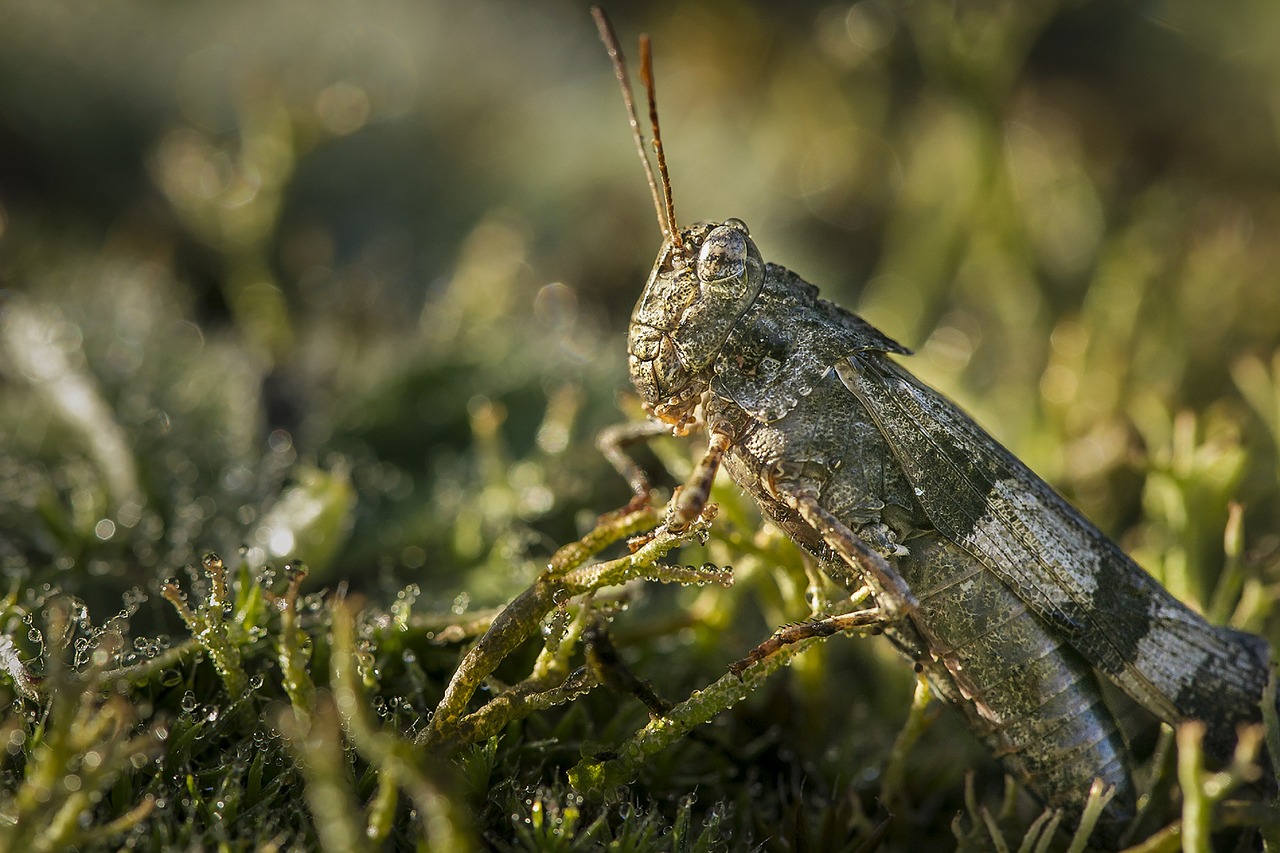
594,9,1270,839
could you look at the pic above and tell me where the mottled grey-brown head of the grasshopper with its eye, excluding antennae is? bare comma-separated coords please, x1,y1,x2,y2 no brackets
627,219,764,423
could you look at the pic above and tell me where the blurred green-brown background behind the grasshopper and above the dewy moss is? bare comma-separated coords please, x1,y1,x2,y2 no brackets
0,0,1280,845
